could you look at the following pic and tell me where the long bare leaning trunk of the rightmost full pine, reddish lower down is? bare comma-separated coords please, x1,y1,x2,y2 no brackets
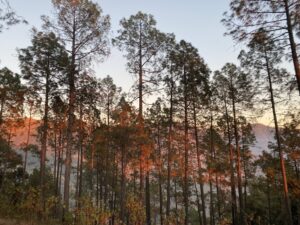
265,51,293,224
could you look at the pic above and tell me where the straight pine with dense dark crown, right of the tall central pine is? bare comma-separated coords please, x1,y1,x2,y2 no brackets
170,41,209,224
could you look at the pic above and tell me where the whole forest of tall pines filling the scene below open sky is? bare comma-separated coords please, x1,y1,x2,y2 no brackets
0,0,300,225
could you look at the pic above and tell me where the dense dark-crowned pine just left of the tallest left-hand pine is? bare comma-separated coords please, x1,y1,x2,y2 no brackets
19,31,68,214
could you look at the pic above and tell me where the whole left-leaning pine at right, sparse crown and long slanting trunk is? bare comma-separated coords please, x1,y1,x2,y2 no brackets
240,29,292,224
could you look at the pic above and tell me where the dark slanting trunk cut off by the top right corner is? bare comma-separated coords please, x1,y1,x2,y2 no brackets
284,0,300,93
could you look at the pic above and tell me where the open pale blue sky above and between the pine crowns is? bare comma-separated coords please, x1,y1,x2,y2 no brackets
0,0,240,90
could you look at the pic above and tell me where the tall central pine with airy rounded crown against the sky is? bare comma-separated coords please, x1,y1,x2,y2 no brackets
113,12,171,225
